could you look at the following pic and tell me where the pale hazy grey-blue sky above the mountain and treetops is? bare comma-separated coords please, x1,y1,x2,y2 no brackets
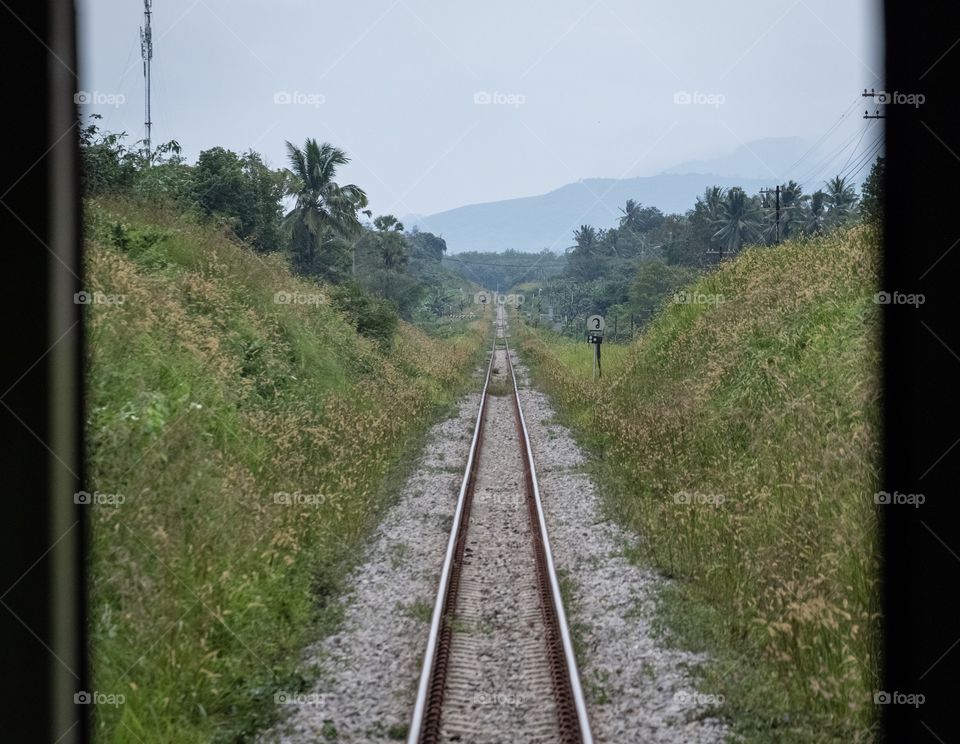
80,0,883,216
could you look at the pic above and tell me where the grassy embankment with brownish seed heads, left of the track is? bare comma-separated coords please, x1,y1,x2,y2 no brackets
86,202,486,744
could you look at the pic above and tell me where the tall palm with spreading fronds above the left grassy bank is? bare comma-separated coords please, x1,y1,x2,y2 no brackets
283,139,367,271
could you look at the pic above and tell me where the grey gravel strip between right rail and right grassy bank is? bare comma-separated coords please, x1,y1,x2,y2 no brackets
511,350,727,744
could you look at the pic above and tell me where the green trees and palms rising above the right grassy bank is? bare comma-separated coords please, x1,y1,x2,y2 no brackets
524,157,884,340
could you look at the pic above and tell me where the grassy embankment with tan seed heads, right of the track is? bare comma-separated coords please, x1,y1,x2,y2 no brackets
523,228,881,742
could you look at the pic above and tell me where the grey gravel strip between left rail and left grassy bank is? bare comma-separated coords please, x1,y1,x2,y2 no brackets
261,392,486,744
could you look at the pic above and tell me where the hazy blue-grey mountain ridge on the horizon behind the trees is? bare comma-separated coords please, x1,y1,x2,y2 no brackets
403,137,869,253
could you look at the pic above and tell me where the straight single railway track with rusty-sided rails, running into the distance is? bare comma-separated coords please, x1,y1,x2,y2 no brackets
407,307,593,744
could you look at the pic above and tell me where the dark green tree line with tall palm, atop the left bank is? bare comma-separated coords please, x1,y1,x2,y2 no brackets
80,115,462,338
